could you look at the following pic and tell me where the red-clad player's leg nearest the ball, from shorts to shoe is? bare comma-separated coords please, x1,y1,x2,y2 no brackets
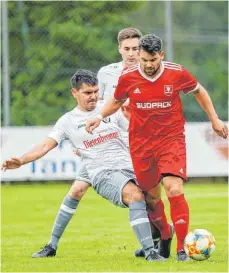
158,135,189,261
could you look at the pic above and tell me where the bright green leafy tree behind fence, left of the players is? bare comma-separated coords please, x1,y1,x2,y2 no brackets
9,1,144,125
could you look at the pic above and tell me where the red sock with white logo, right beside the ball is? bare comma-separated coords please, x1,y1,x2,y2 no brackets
168,194,189,251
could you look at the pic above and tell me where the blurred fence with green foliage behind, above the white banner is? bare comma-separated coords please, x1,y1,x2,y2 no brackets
1,1,228,126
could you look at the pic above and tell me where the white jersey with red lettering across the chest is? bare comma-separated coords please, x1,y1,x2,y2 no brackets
49,102,133,179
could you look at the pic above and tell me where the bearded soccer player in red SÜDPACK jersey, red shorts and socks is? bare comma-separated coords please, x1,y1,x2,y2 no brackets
86,34,228,261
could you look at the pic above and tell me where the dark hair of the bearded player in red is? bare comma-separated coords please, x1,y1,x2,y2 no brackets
139,34,162,54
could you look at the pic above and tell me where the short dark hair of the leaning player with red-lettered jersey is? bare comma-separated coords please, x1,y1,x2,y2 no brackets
71,69,98,89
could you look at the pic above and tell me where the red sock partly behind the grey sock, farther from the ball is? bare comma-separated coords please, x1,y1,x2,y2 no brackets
148,200,171,239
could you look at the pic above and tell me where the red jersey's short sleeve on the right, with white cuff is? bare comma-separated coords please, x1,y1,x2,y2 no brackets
177,68,199,94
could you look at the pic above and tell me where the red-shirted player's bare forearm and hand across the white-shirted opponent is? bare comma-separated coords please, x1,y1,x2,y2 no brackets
85,98,125,134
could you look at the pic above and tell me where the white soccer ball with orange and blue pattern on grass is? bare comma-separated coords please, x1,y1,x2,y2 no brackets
184,229,215,261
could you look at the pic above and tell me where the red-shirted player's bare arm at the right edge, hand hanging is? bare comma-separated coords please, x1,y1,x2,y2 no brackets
194,85,228,139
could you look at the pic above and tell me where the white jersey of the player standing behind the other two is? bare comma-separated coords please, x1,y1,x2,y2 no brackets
97,62,124,100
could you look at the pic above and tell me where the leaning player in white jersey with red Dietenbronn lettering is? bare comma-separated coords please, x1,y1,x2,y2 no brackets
2,69,165,261
